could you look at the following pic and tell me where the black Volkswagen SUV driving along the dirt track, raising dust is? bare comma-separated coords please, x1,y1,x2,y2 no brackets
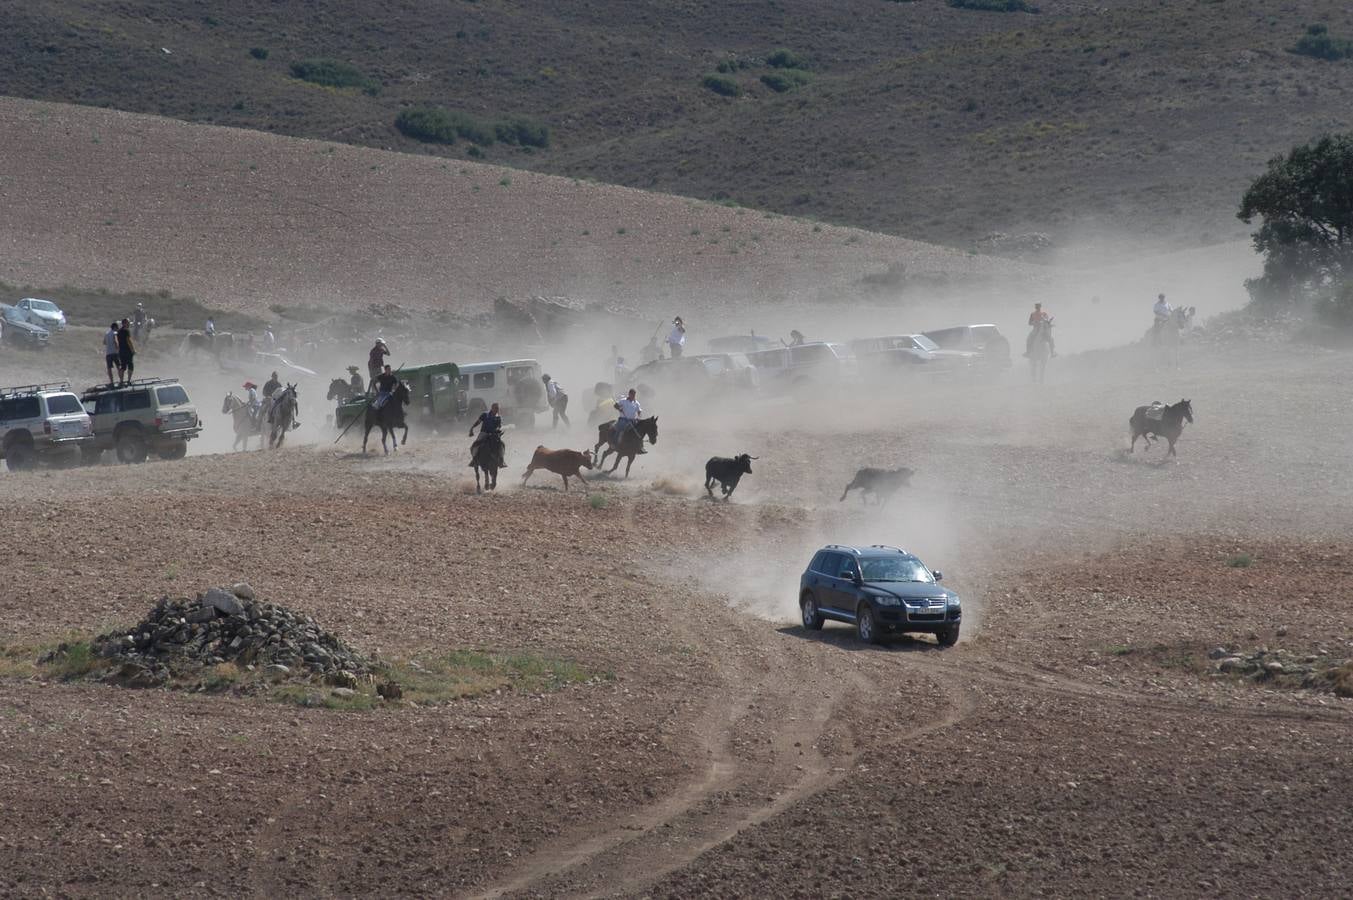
798,544,963,647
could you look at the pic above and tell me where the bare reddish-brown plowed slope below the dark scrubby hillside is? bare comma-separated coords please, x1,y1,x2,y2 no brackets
0,99,1043,321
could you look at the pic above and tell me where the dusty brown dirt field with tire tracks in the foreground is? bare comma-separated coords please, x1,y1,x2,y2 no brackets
0,332,1353,897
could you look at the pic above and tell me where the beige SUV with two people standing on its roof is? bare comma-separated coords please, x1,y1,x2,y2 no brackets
81,378,202,463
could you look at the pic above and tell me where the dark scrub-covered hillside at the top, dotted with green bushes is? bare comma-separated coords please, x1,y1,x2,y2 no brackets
0,0,1353,244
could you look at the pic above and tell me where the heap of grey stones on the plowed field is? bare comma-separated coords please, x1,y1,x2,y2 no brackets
92,582,372,688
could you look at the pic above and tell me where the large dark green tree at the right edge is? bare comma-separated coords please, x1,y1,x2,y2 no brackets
1238,134,1353,303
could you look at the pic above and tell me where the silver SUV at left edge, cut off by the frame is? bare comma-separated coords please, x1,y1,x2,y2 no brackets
0,383,93,471
